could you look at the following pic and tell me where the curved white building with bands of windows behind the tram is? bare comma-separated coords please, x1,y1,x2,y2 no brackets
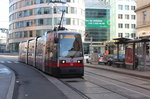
9,0,85,52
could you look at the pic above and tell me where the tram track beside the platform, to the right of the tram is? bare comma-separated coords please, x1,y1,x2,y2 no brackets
85,71,150,99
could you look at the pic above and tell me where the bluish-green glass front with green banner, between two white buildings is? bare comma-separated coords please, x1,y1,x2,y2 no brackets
85,9,110,41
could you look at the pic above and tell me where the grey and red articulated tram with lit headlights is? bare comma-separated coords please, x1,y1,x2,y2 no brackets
19,30,84,76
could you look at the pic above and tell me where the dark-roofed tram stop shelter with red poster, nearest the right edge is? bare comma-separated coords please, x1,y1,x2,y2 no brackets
125,38,150,70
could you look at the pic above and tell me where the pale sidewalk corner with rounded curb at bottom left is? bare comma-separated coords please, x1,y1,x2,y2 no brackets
0,64,15,99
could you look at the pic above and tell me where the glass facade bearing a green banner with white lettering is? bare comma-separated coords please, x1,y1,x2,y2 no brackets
84,9,110,54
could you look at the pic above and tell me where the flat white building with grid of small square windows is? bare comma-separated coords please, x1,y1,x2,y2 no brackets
110,0,136,40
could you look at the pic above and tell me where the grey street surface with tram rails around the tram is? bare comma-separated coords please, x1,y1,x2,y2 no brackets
0,55,150,99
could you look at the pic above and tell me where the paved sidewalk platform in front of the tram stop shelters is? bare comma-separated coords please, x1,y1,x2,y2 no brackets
85,63,150,79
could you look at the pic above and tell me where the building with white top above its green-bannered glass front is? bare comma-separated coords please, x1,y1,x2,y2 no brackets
84,0,110,54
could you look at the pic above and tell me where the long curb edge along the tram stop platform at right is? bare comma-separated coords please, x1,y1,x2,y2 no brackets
85,64,150,79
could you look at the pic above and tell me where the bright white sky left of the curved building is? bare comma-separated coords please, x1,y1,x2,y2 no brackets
0,0,9,28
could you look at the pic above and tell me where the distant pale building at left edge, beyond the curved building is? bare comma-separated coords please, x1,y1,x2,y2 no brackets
0,28,8,52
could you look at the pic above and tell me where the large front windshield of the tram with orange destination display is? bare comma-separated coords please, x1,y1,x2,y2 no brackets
59,33,83,58
